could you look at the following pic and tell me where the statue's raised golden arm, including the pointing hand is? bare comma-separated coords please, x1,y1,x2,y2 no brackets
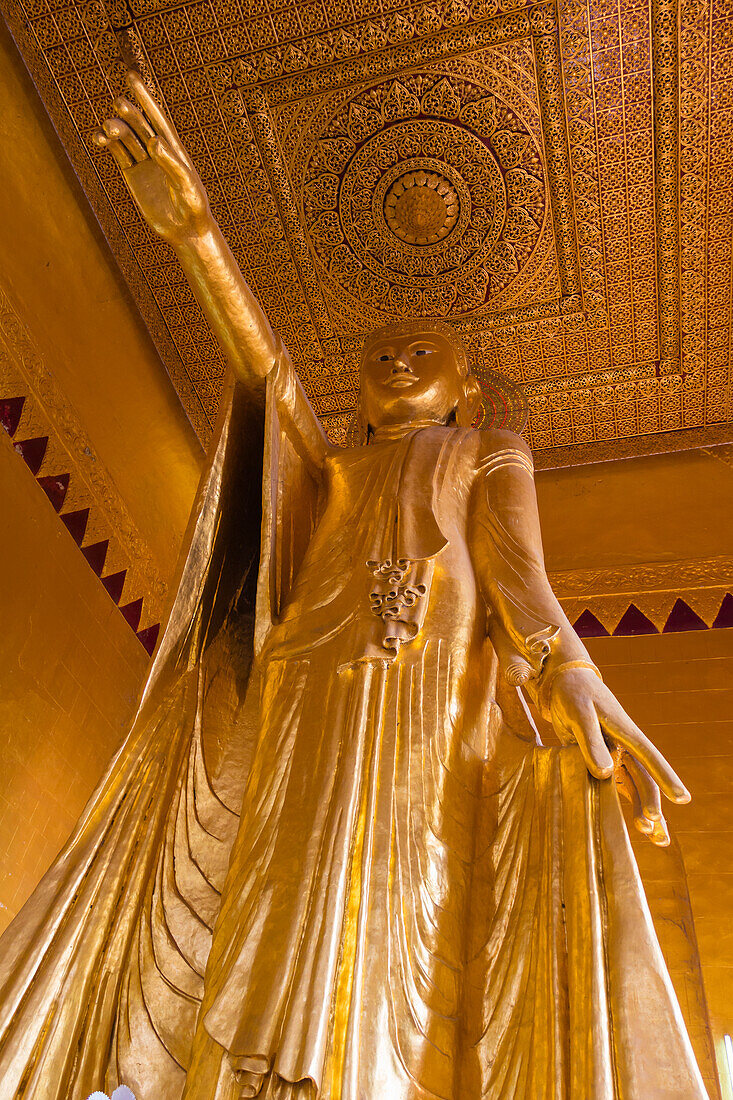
95,73,328,465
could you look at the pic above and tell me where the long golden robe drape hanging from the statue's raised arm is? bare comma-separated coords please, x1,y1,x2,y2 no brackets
0,365,274,1100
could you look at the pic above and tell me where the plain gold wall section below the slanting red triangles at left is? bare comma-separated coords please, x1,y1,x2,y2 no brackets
0,430,147,928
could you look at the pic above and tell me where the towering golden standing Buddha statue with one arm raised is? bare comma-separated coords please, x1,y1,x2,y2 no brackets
0,74,705,1100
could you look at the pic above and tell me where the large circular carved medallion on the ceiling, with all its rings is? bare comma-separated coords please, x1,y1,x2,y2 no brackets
293,73,547,323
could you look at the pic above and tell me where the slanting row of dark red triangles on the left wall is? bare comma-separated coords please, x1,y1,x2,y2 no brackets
0,396,161,656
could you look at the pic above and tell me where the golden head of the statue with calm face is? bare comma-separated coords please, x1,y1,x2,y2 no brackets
360,332,467,428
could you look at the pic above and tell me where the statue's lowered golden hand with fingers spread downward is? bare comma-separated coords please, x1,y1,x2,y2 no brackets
549,668,690,847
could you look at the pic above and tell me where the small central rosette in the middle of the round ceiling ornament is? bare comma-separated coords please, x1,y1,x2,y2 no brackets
384,168,460,244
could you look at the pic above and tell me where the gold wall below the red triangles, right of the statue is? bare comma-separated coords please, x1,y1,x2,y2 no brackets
588,629,733,1100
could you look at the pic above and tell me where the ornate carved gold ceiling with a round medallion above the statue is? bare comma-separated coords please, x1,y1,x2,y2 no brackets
2,0,733,463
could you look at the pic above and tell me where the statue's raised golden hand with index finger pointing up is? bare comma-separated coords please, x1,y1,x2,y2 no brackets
94,72,212,245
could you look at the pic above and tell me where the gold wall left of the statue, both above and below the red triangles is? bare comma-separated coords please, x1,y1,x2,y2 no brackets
0,17,203,928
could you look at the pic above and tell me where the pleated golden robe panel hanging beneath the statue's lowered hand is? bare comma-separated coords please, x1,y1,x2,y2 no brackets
456,734,707,1100
